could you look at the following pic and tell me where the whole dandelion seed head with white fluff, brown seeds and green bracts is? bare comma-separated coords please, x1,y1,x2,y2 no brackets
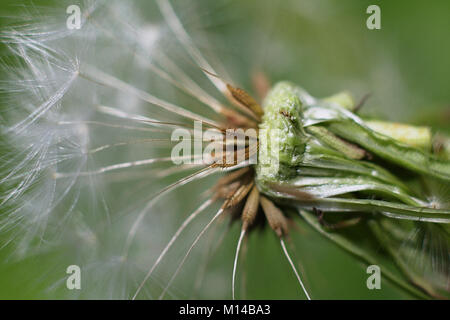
0,0,450,299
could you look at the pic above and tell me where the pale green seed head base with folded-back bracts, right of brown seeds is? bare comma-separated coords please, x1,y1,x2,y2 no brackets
256,82,450,223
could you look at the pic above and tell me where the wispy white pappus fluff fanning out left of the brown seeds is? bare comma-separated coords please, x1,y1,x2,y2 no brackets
0,1,232,298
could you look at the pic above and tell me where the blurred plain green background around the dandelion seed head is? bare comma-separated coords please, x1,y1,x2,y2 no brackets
0,0,450,299
